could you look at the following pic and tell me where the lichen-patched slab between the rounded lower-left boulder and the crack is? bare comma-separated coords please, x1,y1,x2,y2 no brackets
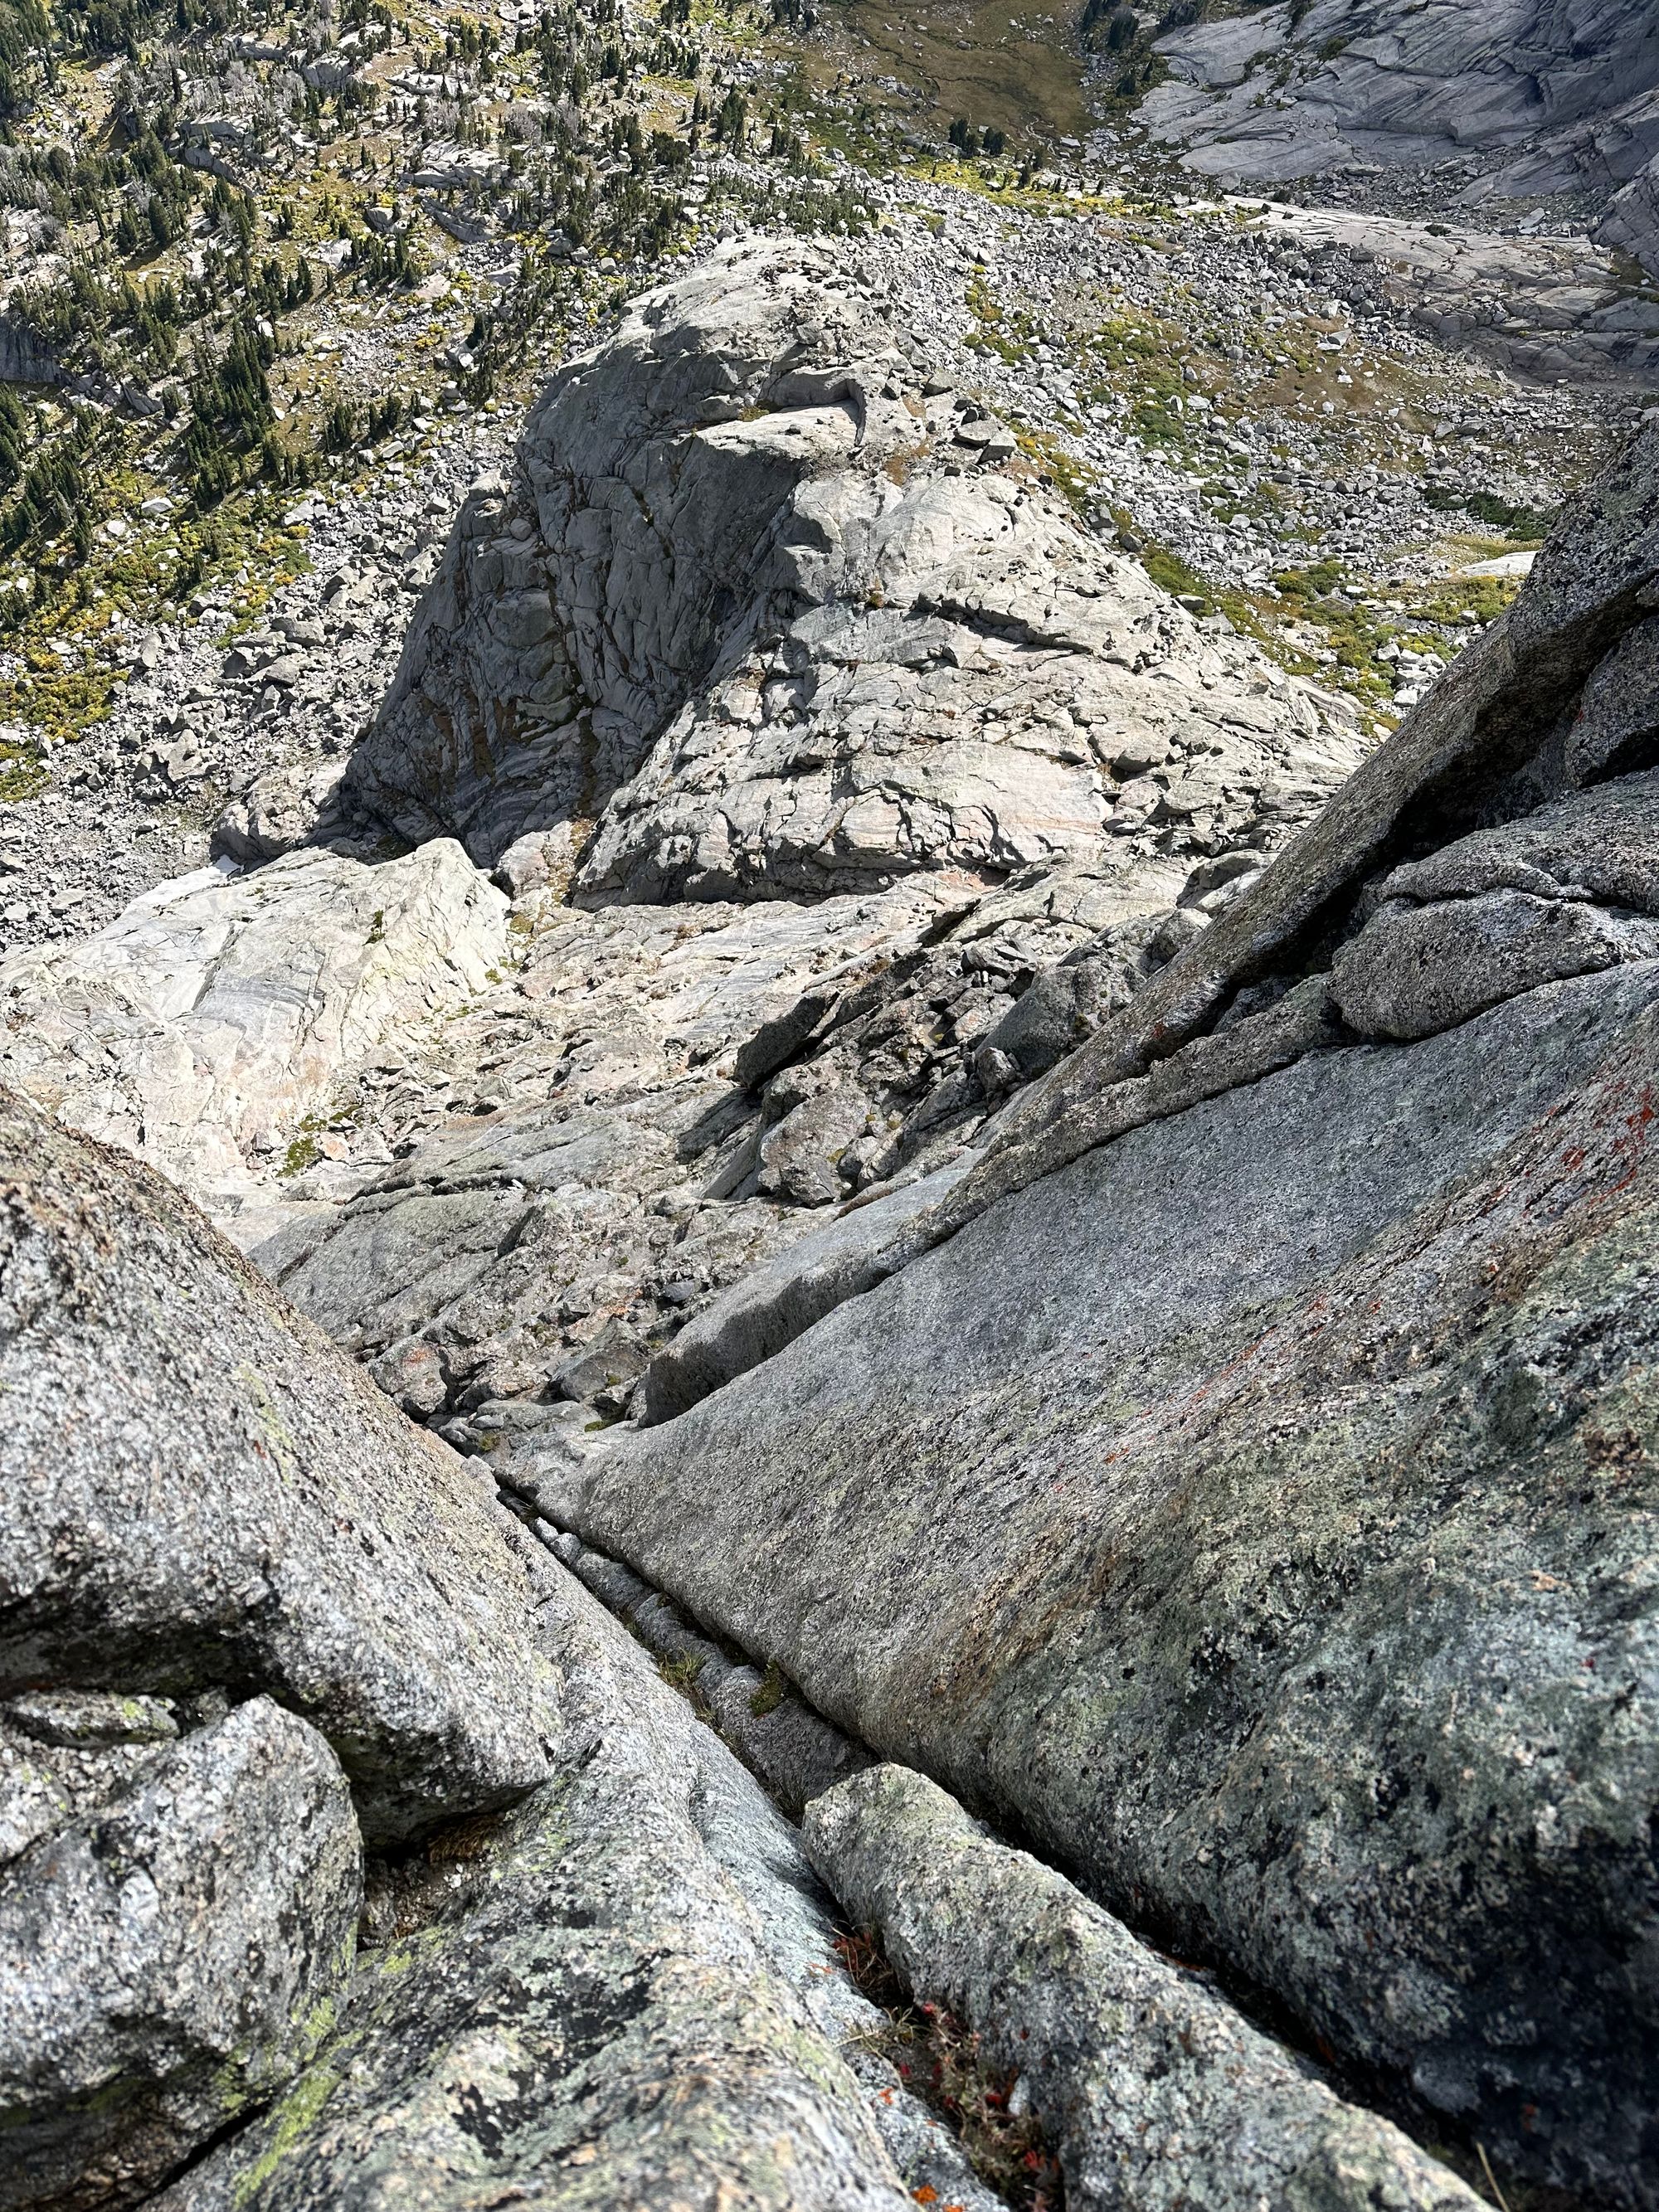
159,1521,973,2212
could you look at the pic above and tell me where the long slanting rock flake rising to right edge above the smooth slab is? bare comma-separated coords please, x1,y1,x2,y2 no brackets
958,416,1659,1210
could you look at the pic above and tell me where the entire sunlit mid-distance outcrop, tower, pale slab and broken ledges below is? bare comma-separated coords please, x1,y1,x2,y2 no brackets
0,243,1365,1440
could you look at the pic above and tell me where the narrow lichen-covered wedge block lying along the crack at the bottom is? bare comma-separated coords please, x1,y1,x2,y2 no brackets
805,1767,1482,2212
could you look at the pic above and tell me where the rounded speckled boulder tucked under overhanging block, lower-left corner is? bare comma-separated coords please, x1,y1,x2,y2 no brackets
0,1699,362,2205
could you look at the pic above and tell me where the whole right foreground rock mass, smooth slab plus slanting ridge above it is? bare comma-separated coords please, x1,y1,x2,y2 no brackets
508,422,1659,2205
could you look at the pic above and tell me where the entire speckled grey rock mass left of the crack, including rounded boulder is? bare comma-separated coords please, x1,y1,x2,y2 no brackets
0,1099,995,2212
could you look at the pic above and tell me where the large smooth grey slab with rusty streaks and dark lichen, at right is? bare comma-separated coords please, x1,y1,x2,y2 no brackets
518,966,1659,2195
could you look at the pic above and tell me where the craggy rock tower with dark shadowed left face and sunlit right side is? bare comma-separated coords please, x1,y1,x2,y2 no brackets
348,243,1358,900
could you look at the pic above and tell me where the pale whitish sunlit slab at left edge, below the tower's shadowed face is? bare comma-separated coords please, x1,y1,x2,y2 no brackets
0,843,507,1206
